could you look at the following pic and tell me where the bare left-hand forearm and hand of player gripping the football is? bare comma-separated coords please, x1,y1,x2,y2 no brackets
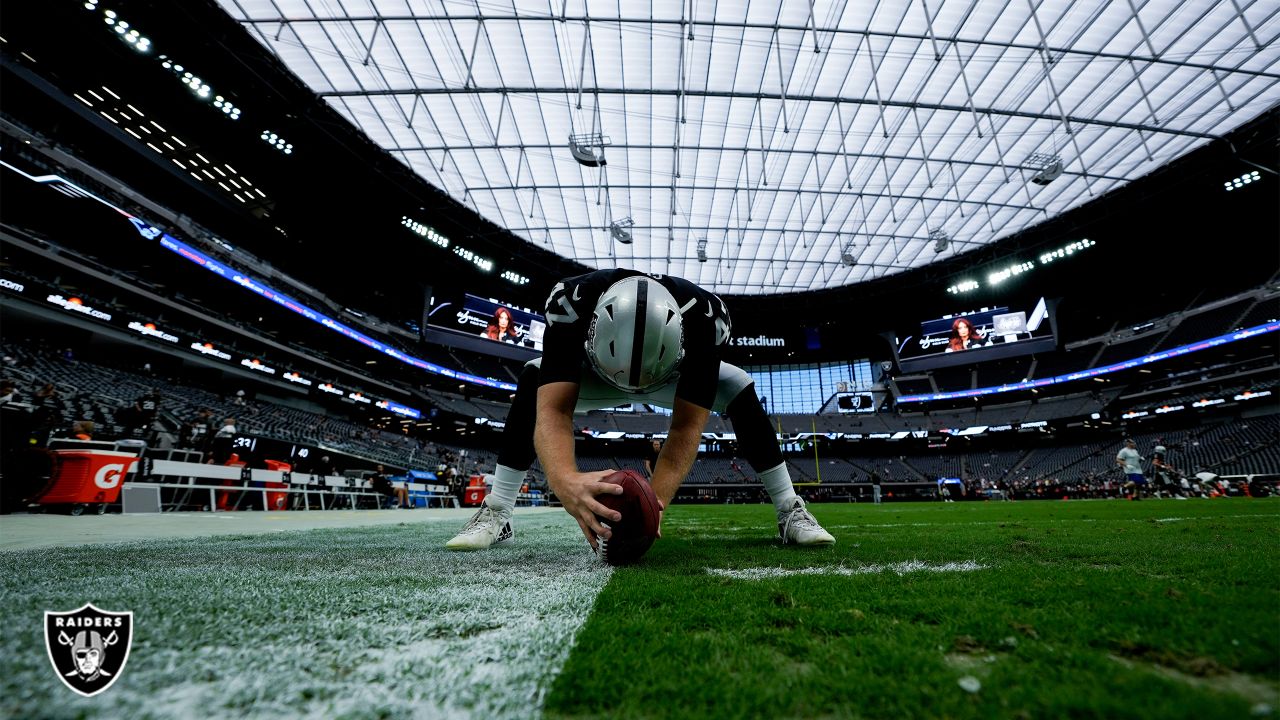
534,382,622,548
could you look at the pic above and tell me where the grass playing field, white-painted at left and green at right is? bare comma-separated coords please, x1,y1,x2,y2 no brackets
0,500,1280,719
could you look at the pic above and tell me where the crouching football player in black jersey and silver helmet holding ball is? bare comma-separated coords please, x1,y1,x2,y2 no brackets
445,269,836,550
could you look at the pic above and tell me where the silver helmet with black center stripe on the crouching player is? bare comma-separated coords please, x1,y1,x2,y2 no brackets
586,275,685,395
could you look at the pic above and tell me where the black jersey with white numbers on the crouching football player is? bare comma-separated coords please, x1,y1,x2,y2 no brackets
540,269,732,409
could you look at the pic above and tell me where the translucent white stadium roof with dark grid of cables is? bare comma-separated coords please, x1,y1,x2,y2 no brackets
219,0,1280,295
